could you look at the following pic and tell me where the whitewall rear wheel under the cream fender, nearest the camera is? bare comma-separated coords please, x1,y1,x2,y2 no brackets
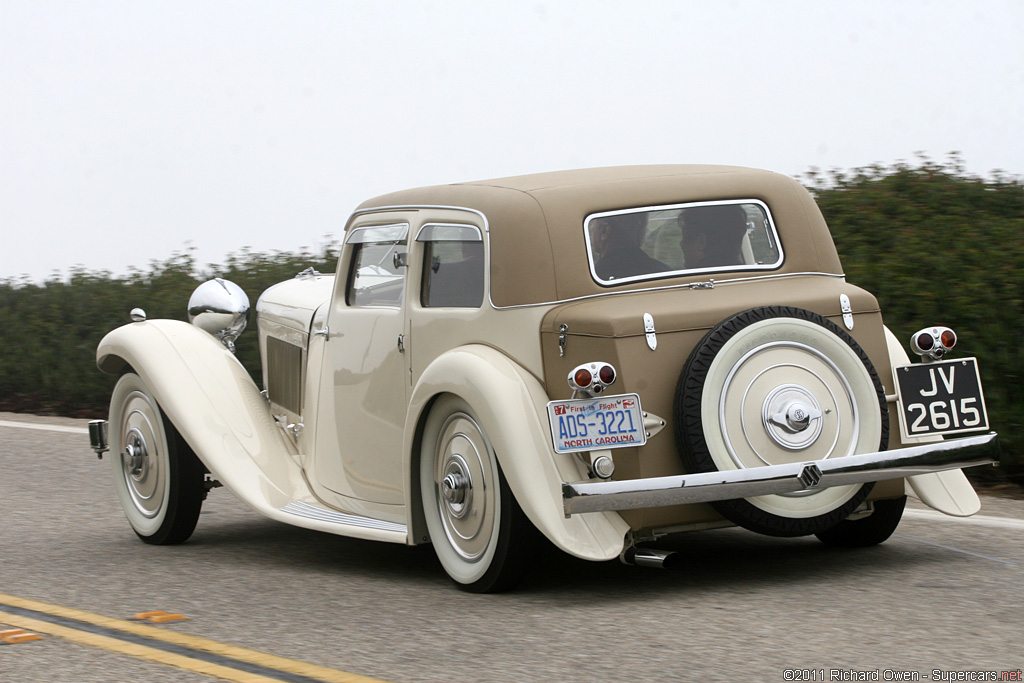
420,395,532,593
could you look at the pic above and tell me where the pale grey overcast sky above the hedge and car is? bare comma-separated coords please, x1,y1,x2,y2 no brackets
0,0,1024,280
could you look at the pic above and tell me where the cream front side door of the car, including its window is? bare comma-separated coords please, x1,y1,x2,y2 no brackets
313,222,410,505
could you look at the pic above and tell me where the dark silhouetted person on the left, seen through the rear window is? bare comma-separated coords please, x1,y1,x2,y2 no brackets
590,213,672,280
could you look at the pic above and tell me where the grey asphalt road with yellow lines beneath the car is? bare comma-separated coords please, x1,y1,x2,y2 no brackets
0,414,1024,683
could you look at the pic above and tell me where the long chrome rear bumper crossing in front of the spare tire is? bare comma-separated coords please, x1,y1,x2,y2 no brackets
562,432,999,517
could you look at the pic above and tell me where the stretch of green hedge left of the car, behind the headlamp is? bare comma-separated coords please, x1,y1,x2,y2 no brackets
0,245,338,418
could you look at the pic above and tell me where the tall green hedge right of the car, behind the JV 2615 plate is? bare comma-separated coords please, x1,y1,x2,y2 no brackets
806,156,1024,483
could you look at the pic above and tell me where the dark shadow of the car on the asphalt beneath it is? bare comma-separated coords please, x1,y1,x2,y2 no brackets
169,517,954,599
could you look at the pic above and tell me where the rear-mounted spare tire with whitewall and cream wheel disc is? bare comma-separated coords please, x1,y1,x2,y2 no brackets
674,306,889,537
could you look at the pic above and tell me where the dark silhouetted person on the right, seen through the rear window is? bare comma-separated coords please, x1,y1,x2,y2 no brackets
677,204,746,269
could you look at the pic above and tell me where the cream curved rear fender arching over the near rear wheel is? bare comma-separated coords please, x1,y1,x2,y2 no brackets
404,344,629,560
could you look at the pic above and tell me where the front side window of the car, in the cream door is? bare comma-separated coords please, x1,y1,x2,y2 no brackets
345,223,409,307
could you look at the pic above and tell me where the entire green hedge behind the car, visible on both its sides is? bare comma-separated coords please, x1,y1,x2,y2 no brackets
0,156,1024,478
